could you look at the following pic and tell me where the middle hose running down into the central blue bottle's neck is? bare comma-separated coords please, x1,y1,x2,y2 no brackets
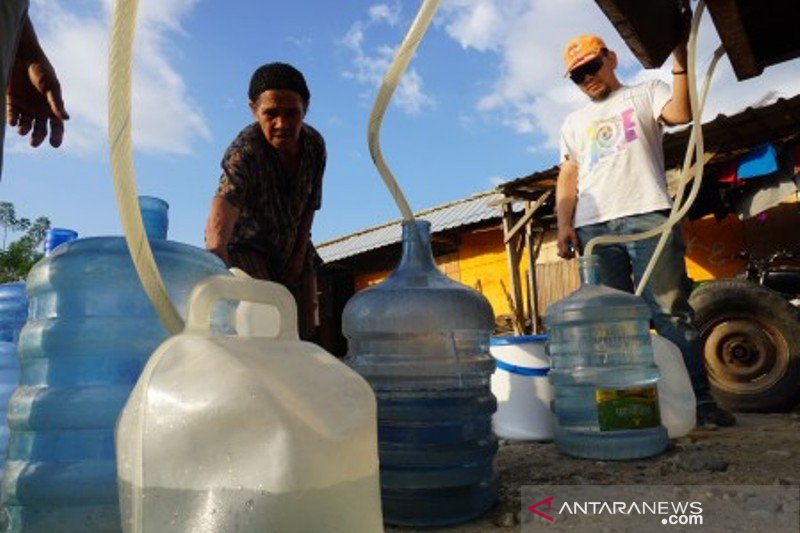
367,0,440,221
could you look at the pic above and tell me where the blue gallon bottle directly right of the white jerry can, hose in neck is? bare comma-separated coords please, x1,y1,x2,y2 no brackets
342,221,497,526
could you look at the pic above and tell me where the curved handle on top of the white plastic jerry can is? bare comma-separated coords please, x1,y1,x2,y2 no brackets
186,272,299,340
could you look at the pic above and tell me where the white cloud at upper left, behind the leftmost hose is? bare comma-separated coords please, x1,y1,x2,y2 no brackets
19,0,211,155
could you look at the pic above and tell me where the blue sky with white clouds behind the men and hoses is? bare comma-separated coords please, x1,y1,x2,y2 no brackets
0,0,800,246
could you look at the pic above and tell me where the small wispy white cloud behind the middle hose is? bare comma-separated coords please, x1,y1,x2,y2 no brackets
339,3,436,114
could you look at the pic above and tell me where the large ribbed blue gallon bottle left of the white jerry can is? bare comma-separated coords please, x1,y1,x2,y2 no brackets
2,196,227,532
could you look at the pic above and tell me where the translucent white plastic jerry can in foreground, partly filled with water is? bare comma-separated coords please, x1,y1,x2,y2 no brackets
115,276,383,533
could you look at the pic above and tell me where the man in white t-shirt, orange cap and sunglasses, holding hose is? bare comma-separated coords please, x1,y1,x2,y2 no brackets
556,35,736,426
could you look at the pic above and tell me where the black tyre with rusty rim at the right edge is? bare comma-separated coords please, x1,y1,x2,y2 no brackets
689,279,800,412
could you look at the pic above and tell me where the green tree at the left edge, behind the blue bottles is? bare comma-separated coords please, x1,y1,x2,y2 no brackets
0,202,50,283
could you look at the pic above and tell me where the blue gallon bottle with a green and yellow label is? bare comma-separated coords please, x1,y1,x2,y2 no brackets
544,255,669,460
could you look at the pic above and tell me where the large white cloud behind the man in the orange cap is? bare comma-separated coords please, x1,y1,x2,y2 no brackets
442,0,800,149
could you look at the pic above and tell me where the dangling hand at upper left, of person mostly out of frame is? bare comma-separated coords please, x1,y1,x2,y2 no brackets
6,58,69,148
